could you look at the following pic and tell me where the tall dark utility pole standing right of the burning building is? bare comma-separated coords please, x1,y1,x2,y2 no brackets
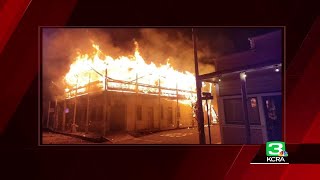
192,28,206,144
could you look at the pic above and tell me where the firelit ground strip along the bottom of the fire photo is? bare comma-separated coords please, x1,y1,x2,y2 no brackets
43,125,221,145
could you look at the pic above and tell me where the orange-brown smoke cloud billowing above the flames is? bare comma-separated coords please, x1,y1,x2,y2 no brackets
42,28,215,94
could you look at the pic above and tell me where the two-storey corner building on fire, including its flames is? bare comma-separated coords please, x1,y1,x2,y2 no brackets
46,42,216,135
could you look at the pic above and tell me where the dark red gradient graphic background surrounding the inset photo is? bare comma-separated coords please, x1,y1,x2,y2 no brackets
0,0,320,179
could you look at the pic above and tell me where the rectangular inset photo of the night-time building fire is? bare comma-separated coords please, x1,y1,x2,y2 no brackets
40,27,284,146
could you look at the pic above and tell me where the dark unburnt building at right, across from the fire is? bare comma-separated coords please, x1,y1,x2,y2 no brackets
215,31,283,144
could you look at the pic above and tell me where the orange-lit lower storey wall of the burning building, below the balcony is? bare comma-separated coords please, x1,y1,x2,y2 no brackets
48,91,196,134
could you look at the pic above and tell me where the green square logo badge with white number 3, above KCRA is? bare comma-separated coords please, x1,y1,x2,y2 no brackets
266,141,288,157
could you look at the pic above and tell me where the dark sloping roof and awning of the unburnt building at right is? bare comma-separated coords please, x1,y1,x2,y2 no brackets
200,31,283,81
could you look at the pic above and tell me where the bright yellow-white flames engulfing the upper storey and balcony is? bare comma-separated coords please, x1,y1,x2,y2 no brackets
64,41,196,104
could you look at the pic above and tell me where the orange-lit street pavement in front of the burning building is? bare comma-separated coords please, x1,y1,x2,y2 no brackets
43,125,221,145
